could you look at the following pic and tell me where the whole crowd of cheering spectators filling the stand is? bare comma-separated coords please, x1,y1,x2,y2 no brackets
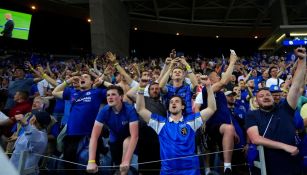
0,48,307,175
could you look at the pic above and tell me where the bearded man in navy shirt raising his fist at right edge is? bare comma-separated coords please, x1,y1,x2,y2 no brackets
245,48,306,175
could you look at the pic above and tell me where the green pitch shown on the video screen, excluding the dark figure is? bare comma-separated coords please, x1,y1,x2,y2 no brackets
0,9,32,40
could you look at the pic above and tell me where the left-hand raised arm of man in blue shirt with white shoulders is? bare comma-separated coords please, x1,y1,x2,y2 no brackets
136,77,151,123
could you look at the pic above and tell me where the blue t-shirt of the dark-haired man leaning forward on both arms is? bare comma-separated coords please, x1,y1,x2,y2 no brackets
96,103,139,143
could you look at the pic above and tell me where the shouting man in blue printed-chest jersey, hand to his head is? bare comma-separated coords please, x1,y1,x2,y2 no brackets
52,74,106,174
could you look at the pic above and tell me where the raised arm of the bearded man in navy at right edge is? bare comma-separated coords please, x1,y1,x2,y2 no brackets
287,47,306,109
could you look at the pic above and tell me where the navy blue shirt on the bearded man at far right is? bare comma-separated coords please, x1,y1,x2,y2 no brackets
245,100,301,175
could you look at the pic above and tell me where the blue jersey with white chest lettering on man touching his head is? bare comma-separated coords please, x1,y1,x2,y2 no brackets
63,88,106,136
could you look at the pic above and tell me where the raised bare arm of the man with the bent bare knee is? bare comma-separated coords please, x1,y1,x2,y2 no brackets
212,51,238,92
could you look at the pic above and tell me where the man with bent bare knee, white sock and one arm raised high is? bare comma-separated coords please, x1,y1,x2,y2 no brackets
195,50,238,175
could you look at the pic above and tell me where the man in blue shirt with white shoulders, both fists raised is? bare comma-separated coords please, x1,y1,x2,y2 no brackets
136,76,216,175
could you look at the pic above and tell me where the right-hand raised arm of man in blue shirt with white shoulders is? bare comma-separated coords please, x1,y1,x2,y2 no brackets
200,75,216,122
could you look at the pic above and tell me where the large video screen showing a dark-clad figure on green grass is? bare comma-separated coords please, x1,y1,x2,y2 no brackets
0,8,32,40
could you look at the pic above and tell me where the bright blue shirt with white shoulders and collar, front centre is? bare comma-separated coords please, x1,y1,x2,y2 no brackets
148,112,203,175
